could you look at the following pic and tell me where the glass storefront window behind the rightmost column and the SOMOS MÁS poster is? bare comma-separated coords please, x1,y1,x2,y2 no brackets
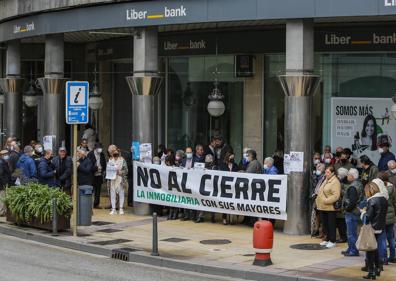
264,53,396,155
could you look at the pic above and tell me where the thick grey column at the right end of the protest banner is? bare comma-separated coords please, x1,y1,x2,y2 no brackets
279,20,319,235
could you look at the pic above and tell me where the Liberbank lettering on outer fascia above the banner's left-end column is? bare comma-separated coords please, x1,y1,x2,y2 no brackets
126,5,187,21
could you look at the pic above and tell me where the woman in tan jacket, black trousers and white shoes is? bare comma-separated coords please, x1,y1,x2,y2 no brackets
316,166,341,248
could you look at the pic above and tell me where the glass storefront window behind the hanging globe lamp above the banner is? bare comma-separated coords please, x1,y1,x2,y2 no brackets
167,56,244,160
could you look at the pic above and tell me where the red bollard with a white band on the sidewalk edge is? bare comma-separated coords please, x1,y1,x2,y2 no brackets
253,220,274,266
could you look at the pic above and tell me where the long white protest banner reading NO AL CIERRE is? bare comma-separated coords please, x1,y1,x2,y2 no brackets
133,161,287,220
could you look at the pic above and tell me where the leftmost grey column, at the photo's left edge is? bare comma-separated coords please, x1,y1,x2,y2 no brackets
0,40,24,139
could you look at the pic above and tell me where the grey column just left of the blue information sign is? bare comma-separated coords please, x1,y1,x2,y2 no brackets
38,34,66,149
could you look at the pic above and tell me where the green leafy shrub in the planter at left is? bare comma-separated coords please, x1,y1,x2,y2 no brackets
4,183,73,223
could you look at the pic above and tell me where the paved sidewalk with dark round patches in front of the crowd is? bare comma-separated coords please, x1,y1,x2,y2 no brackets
0,206,396,281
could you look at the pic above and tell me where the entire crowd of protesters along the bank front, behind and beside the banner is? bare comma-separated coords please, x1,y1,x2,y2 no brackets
0,131,396,279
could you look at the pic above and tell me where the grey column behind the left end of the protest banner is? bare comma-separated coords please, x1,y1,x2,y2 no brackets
126,27,162,215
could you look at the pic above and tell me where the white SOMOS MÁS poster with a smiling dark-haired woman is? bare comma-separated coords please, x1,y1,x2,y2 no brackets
331,98,396,164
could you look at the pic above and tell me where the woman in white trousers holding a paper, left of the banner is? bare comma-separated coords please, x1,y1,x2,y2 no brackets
106,144,128,215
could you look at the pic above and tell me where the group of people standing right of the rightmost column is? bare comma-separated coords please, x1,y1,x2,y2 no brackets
311,135,396,279
